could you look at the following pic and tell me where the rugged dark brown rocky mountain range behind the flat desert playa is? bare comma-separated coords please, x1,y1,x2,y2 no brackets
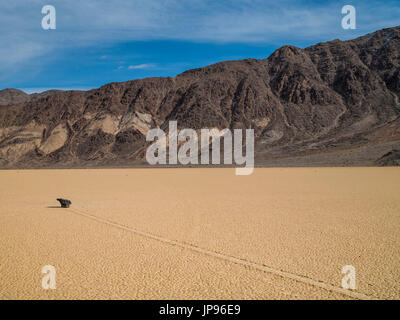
0,27,400,168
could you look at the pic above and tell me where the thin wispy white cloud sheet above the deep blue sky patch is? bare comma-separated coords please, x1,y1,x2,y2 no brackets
0,0,400,84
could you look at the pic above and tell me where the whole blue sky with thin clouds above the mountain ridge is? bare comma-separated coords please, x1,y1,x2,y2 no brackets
0,0,400,93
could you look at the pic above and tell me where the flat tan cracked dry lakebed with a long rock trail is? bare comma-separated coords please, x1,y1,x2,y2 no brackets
0,168,400,299
